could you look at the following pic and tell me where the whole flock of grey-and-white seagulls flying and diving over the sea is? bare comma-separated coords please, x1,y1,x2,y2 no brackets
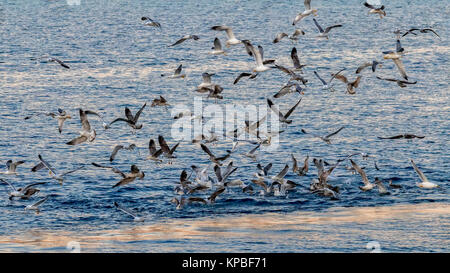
0,0,440,222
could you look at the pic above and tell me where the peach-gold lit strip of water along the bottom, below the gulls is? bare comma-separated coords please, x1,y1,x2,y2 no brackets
0,203,450,252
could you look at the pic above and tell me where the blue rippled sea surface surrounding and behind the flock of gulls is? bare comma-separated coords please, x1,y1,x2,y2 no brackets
0,0,450,251
